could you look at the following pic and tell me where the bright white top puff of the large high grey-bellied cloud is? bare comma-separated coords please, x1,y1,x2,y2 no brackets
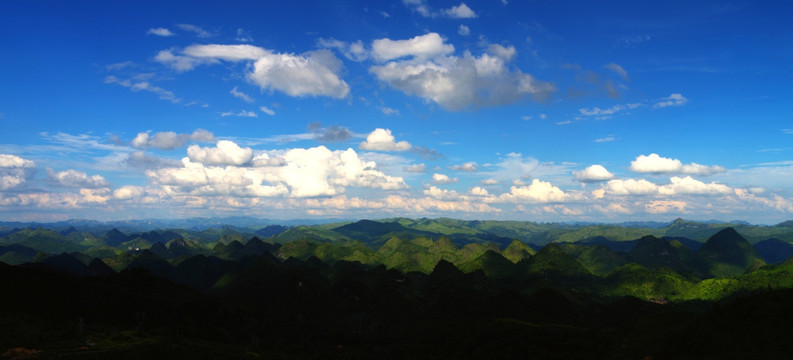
372,33,454,62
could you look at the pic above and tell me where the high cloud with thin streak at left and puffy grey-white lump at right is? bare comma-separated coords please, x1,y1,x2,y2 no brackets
155,44,350,99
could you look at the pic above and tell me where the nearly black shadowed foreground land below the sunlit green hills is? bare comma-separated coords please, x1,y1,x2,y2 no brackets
0,253,793,359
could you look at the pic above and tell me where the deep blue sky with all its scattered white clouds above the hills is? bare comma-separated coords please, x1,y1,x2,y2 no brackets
0,0,793,224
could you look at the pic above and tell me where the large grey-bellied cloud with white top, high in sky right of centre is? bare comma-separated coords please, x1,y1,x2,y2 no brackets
369,33,556,111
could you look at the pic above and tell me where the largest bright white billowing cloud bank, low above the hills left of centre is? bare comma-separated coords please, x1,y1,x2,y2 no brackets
146,142,407,198
